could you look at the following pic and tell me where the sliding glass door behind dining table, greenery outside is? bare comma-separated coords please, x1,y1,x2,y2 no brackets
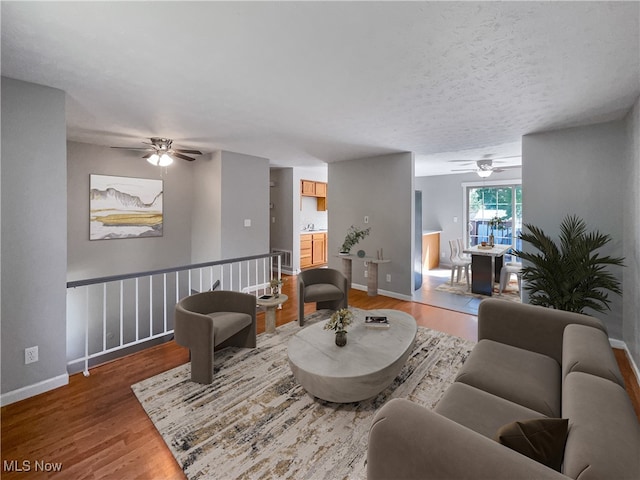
463,180,522,250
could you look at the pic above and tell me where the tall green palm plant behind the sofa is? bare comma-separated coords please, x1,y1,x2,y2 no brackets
515,215,624,313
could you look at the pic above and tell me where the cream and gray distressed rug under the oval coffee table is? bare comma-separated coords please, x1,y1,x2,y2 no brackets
132,309,474,480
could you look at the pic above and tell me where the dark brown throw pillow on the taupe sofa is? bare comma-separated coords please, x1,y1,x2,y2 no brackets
495,418,569,471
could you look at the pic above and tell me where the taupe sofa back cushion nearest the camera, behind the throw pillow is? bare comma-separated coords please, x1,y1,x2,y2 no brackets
562,372,640,480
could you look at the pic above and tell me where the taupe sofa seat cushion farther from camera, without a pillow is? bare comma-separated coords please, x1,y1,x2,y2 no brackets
456,340,561,417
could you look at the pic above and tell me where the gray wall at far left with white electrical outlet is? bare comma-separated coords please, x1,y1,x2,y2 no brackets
1,77,67,403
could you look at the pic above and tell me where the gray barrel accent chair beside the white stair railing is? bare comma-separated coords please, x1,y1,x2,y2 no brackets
174,291,256,384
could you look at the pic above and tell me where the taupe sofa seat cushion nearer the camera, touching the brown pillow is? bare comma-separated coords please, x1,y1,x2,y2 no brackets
433,382,546,438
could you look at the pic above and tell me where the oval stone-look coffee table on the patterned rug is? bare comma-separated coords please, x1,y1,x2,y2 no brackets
287,310,418,403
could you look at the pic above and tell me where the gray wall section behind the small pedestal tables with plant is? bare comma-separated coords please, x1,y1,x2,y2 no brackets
327,153,414,298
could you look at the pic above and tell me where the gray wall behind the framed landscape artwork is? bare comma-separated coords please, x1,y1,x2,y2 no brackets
67,142,193,281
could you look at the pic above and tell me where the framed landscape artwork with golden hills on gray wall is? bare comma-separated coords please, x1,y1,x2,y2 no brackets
89,175,163,240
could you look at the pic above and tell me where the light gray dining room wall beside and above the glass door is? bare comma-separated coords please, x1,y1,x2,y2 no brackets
415,168,522,265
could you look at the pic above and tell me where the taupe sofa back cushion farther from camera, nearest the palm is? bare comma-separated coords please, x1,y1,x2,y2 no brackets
562,324,624,387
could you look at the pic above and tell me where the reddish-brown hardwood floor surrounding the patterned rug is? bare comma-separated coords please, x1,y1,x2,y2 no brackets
0,277,640,480
